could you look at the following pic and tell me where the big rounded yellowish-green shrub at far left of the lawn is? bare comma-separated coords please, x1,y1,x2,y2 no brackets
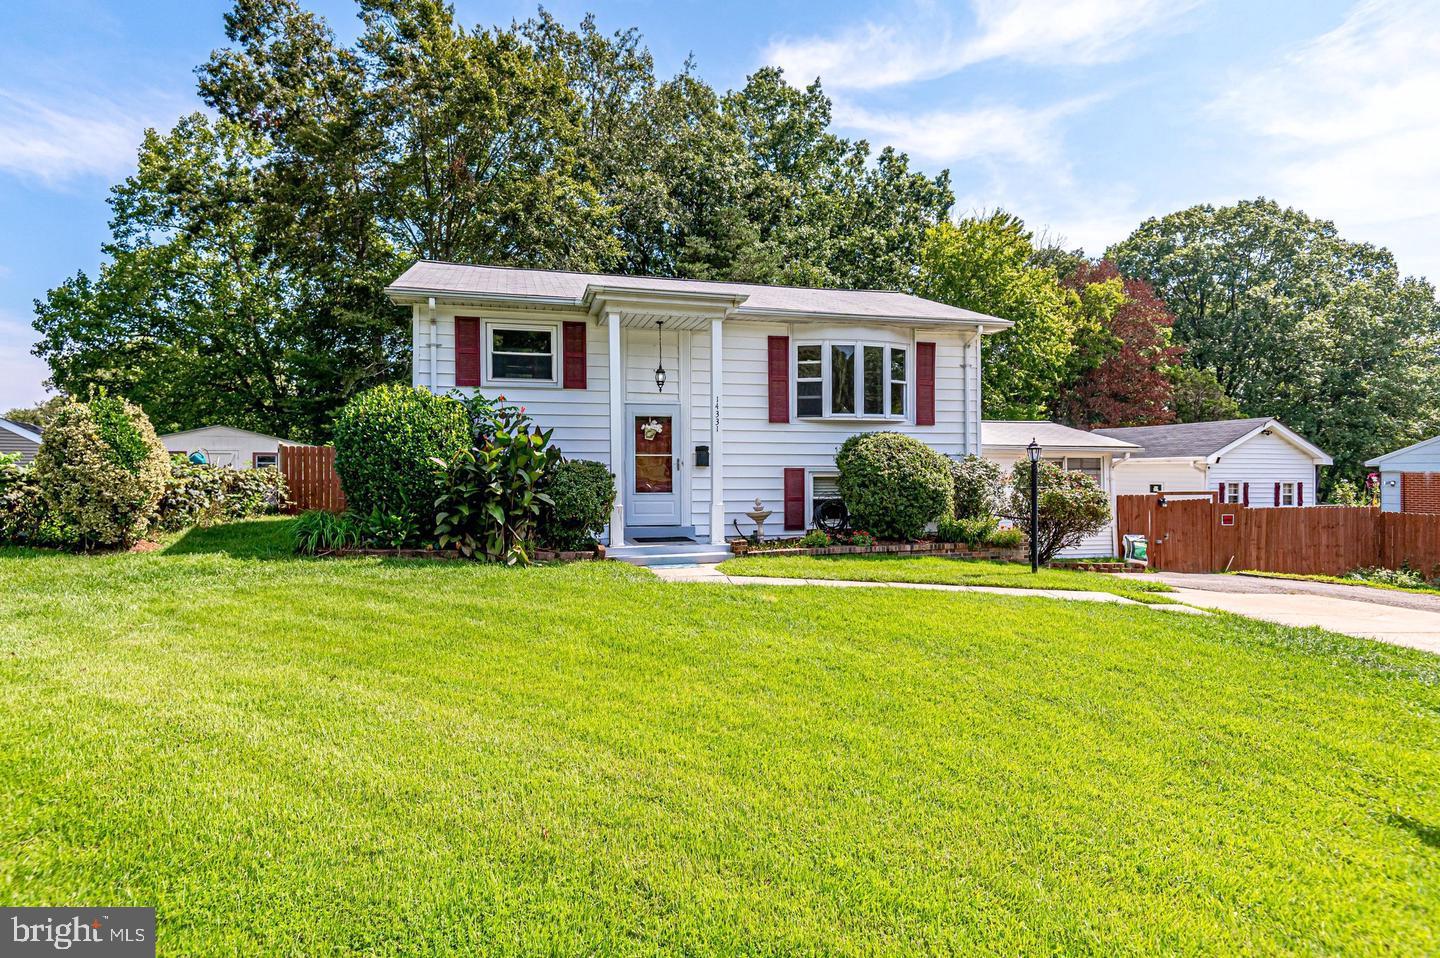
35,395,170,549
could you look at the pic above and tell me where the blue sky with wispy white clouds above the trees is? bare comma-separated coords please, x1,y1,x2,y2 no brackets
0,0,1440,409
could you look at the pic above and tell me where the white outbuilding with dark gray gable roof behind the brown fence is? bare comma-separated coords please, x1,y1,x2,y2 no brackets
1096,418,1331,507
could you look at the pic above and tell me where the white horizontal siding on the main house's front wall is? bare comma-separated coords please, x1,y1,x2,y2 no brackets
412,307,981,539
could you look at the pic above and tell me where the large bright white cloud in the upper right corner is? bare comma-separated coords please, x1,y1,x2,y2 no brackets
1215,0,1440,279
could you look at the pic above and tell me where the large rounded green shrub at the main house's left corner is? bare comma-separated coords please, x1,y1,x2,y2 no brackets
334,385,471,529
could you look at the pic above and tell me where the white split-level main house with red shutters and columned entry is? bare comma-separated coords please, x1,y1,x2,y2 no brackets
387,261,1008,546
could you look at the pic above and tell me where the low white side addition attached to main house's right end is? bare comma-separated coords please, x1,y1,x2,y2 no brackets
981,419,1139,558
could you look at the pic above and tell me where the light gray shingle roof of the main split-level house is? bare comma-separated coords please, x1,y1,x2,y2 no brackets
386,259,1009,327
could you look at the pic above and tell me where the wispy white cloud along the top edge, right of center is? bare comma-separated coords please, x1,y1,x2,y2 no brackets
765,0,1202,89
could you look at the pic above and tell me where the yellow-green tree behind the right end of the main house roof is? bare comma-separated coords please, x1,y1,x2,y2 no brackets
917,212,1076,419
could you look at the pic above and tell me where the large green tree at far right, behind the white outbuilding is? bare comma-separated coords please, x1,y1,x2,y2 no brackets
1109,199,1440,478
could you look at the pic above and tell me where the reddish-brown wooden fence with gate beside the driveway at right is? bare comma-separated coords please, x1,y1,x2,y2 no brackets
1115,493,1440,575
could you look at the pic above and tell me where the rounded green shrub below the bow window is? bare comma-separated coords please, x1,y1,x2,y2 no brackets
835,432,955,540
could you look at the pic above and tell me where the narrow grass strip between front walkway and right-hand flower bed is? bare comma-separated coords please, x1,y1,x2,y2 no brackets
720,556,1174,602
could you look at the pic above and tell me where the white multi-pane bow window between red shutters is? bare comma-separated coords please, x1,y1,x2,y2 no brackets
795,341,910,419
